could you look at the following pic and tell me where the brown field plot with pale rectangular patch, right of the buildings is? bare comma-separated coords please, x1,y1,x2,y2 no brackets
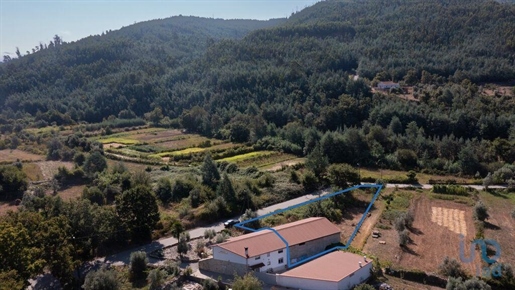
364,193,481,273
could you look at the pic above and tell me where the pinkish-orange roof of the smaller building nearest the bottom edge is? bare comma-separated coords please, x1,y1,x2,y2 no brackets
280,251,372,282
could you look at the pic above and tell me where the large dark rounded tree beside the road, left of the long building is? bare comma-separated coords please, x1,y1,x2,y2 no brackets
116,185,159,240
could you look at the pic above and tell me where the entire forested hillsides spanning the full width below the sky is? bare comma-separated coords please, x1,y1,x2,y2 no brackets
0,0,515,168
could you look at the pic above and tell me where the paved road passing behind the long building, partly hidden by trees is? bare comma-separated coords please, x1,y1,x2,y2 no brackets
104,184,505,265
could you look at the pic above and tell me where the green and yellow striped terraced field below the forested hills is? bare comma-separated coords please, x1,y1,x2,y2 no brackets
91,128,304,171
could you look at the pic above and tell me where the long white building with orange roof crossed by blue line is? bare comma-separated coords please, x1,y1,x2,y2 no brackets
205,217,340,275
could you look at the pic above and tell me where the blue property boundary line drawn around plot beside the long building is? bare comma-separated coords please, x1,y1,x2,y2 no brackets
234,184,383,268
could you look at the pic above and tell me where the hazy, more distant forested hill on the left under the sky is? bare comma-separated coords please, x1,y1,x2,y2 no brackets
0,16,286,123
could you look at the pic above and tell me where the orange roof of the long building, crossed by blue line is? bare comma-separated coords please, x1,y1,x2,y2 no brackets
217,217,340,257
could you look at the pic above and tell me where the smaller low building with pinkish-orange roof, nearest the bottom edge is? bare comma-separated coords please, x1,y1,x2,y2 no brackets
276,251,372,290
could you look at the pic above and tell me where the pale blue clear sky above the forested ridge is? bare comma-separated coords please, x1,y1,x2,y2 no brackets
0,0,318,57
